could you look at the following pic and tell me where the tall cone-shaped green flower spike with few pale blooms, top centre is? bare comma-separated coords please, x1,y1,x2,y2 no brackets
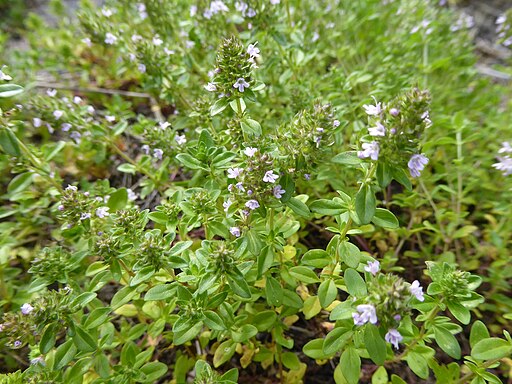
205,36,260,100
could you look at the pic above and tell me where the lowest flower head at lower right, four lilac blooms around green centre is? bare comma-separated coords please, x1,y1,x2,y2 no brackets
352,261,425,349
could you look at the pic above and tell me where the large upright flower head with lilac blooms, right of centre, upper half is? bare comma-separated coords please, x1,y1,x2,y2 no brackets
357,88,432,177
